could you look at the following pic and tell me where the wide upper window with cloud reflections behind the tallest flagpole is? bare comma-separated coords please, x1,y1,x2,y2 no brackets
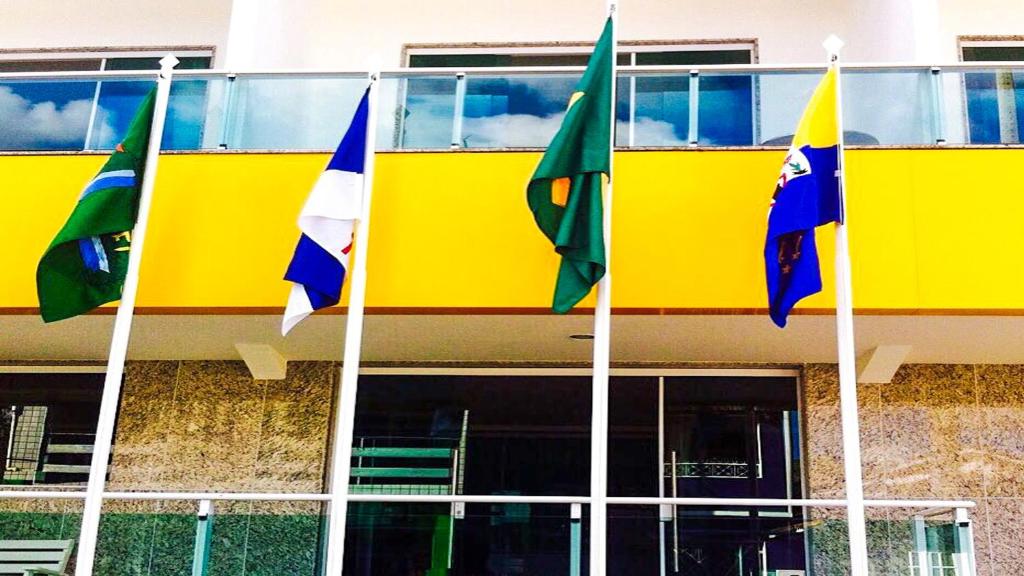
395,41,756,148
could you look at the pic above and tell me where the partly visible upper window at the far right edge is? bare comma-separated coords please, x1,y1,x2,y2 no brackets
961,39,1024,143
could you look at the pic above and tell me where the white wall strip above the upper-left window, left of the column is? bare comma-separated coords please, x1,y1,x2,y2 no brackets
0,0,231,63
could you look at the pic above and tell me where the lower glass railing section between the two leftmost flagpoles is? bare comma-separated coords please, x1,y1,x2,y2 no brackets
95,500,326,576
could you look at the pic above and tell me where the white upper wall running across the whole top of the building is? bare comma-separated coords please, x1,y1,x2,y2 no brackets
0,0,1024,68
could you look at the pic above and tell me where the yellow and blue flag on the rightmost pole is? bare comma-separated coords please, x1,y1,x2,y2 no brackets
765,68,843,328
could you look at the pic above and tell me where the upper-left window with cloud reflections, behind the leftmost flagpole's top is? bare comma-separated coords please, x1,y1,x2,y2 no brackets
0,49,213,151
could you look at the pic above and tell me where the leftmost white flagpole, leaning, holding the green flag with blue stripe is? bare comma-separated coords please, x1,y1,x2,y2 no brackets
75,54,178,576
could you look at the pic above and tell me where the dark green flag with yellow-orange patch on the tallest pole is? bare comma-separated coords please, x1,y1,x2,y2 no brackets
526,18,614,314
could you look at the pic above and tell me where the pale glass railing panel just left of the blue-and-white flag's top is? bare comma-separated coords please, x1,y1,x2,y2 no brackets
220,77,367,151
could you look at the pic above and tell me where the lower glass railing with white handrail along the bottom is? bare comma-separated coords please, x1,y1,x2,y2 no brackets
0,492,977,576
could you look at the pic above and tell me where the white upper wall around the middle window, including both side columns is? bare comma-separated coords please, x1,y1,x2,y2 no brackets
220,0,913,69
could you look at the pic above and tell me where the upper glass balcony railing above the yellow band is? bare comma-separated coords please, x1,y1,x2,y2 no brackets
0,63,1024,152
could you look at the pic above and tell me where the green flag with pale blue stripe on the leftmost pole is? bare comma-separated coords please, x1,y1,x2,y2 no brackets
36,88,157,322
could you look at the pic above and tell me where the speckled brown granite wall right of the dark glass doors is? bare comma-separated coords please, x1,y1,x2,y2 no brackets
802,364,1024,576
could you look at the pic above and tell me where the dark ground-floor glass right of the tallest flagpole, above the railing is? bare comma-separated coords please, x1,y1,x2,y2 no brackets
608,376,802,498
